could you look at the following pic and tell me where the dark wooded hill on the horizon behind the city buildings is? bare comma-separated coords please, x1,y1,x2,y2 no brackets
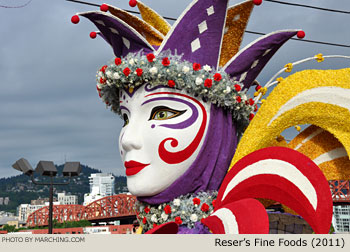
0,165,126,213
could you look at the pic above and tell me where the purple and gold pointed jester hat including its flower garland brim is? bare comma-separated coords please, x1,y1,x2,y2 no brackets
71,0,303,129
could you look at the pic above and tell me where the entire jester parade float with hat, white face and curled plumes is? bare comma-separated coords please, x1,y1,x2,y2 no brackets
71,0,350,234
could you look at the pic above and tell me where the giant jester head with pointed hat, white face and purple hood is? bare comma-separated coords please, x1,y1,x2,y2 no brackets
72,0,297,204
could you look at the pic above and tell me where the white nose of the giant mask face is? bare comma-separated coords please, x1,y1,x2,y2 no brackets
120,122,142,151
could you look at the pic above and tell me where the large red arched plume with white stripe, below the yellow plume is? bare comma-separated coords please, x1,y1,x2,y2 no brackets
216,147,333,233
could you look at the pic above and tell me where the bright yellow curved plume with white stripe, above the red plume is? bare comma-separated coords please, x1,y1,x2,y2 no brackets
230,68,350,169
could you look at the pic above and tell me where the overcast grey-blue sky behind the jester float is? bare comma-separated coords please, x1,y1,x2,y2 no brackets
0,0,350,177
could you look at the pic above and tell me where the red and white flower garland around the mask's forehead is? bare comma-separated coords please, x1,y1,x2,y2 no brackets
97,52,257,130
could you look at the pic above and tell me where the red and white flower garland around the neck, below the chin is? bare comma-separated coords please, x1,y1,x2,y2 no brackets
136,191,217,232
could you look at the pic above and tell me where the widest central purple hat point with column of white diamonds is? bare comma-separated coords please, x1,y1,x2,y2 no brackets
158,0,228,68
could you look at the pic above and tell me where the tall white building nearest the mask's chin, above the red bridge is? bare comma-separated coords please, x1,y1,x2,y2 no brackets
84,173,115,206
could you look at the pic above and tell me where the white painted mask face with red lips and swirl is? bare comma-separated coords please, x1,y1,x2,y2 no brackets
119,84,211,196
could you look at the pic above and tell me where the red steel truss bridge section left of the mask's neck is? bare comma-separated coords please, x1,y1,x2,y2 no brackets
27,194,136,227
